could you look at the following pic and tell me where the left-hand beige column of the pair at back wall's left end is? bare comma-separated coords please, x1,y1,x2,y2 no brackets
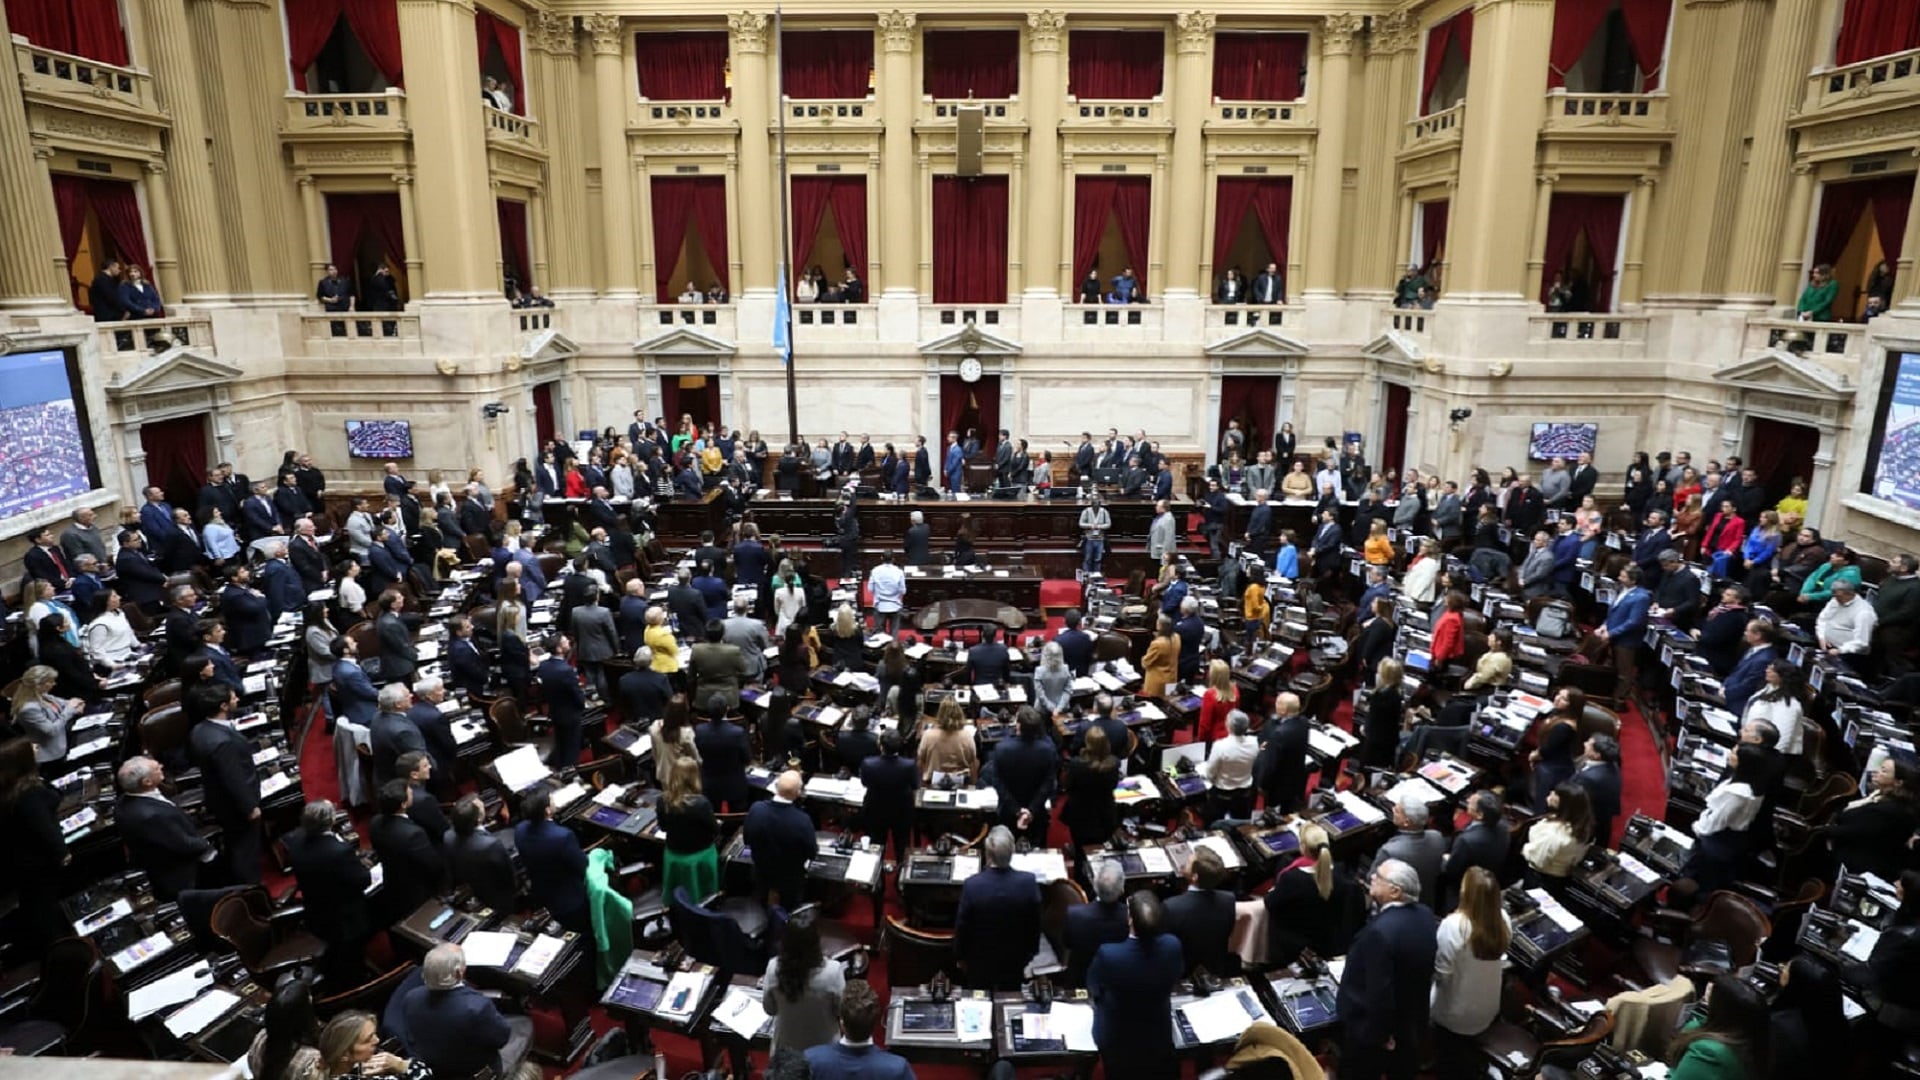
530,12,593,298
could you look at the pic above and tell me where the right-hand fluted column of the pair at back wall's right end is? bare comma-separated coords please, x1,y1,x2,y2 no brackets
1346,12,1419,300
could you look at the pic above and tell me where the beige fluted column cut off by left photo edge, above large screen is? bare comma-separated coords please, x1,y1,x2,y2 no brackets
0,0,73,311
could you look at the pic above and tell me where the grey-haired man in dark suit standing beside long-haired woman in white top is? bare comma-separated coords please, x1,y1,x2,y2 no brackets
1336,859,1440,1080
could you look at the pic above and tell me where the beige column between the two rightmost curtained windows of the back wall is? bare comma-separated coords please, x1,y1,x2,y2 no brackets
1156,12,1213,298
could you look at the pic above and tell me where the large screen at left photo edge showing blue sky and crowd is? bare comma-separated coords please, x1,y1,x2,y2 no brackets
0,350,100,521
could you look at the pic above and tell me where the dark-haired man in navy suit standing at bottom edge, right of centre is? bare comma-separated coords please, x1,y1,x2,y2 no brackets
1087,890,1187,1080
